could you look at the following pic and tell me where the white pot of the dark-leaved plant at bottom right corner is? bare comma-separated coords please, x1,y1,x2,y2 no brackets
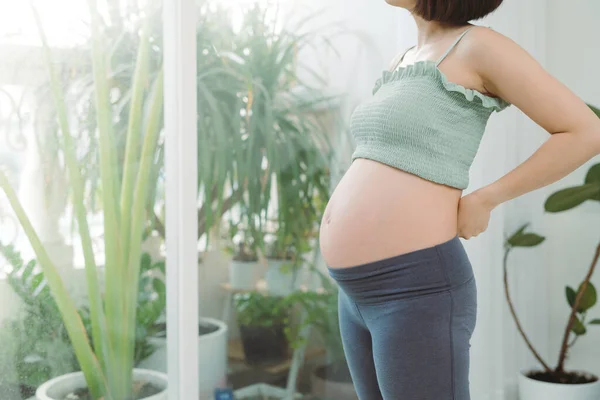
519,371,600,400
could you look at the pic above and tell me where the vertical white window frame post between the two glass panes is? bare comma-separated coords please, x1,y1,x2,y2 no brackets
163,0,200,400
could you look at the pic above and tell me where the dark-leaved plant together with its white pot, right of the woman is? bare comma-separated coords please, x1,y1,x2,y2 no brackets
504,160,600,400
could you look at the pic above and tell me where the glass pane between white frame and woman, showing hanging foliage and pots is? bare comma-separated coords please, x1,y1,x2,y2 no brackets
198,1,342,399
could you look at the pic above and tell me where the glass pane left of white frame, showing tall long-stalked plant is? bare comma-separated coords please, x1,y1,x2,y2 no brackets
0,0,167,400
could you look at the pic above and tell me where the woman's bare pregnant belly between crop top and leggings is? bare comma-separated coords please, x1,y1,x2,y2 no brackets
320,158,462,268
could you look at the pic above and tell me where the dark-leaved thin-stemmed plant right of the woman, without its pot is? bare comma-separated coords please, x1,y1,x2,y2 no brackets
504,158,600,383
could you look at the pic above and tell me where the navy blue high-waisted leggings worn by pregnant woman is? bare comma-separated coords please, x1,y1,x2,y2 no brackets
329,236,477,400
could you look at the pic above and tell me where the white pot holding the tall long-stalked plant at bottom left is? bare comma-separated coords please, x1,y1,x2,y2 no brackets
35,369,167,400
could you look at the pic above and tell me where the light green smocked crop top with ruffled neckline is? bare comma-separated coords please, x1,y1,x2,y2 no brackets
350,27,510,189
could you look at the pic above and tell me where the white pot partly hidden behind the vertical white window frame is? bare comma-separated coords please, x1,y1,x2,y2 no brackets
140,318,227,400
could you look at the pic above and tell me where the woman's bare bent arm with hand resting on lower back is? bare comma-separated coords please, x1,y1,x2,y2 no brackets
459,28,600,238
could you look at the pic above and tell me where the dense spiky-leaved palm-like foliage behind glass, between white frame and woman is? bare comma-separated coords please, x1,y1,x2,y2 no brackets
178,1,331,250
